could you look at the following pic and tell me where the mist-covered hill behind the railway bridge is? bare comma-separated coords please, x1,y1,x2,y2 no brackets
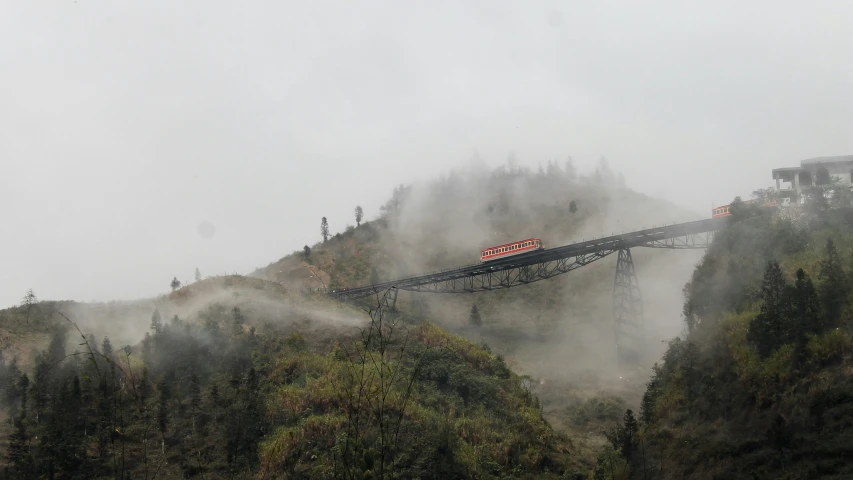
254,161,710,428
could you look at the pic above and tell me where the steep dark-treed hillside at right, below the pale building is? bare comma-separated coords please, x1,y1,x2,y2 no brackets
598,189,853,479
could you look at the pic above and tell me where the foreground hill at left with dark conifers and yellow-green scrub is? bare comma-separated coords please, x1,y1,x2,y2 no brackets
0,276,591,479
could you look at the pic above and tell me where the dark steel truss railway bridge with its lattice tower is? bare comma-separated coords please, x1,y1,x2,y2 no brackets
329,217,730,362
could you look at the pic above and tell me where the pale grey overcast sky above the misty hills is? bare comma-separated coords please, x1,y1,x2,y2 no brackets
0,0,853,305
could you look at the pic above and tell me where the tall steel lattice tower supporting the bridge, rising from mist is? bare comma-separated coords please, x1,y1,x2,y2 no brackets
613,248,645,366
